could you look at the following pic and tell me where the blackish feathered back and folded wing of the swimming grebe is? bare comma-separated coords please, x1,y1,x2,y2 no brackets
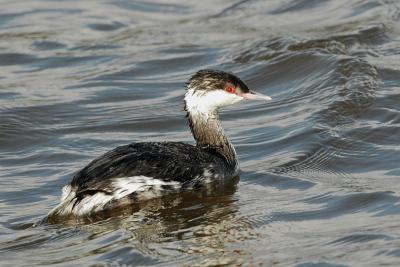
71,142,224,191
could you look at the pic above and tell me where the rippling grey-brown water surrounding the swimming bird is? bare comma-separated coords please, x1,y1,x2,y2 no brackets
0,0,400,267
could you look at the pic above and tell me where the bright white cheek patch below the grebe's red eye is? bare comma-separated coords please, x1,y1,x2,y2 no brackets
185,89,243,113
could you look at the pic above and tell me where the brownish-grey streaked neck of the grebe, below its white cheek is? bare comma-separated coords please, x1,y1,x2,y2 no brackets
185,106,238,171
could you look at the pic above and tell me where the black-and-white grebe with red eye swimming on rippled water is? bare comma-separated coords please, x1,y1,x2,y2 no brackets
49,70,271,219
